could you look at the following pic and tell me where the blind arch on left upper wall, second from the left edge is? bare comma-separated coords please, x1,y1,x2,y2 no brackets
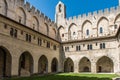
16,7,26,24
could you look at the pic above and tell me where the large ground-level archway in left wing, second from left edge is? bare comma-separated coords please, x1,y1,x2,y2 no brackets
19,52,33,76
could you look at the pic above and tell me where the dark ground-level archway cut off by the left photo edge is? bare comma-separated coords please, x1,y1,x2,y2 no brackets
0,47,12,77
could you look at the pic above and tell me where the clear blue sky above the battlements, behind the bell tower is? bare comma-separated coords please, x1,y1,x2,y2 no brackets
26,0,119,20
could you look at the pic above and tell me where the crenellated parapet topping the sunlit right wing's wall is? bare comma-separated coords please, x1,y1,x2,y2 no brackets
67,6,120,22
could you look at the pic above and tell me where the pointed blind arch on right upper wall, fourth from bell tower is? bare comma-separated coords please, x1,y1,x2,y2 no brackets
97,16,109,36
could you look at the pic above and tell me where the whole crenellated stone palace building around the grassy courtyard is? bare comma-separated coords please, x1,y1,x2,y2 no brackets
0,0,120,77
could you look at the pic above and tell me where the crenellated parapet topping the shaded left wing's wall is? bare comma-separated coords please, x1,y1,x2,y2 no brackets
17,0,56,25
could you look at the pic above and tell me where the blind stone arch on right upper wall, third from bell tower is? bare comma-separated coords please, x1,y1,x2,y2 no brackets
81,20,92,38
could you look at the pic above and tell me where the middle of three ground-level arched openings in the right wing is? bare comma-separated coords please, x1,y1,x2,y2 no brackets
79,57,91,72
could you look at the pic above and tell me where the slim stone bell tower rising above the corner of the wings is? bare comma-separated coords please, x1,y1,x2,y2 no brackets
55,1,66,26
